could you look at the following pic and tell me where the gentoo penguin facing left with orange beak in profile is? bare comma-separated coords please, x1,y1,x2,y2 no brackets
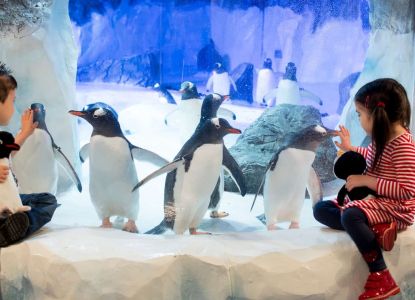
69,102,168,232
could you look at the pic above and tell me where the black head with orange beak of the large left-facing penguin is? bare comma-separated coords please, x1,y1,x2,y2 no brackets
69,102,121,136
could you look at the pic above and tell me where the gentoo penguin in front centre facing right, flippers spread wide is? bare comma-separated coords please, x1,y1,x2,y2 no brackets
136,118,246,234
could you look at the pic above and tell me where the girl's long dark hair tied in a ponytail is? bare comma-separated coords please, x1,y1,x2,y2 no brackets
355,78,411,170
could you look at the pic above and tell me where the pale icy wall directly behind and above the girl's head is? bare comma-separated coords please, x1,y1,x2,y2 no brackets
340,0,415,145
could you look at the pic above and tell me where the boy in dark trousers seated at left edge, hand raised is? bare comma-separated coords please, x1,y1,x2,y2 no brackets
0,63,58,247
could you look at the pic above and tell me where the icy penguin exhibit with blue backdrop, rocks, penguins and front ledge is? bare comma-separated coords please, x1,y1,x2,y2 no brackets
0,0,415,300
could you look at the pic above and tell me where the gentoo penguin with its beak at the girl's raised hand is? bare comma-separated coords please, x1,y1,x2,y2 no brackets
251,125,336,230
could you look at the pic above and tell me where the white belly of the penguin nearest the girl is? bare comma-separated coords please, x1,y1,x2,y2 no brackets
264,148,316,225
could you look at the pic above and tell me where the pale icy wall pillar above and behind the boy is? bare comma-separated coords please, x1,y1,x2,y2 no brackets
0,0,79,191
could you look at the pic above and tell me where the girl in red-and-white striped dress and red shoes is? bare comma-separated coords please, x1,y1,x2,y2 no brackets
314,78,415,299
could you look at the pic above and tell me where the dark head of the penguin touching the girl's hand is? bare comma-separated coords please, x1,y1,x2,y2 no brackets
293,124,337,151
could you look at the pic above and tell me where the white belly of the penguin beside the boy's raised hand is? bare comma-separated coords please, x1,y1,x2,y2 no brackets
12,129,58,194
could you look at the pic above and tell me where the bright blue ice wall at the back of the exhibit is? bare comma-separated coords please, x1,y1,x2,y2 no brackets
70,0,369,86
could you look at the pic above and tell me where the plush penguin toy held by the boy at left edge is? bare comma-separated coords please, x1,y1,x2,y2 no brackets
0,131,23,212
